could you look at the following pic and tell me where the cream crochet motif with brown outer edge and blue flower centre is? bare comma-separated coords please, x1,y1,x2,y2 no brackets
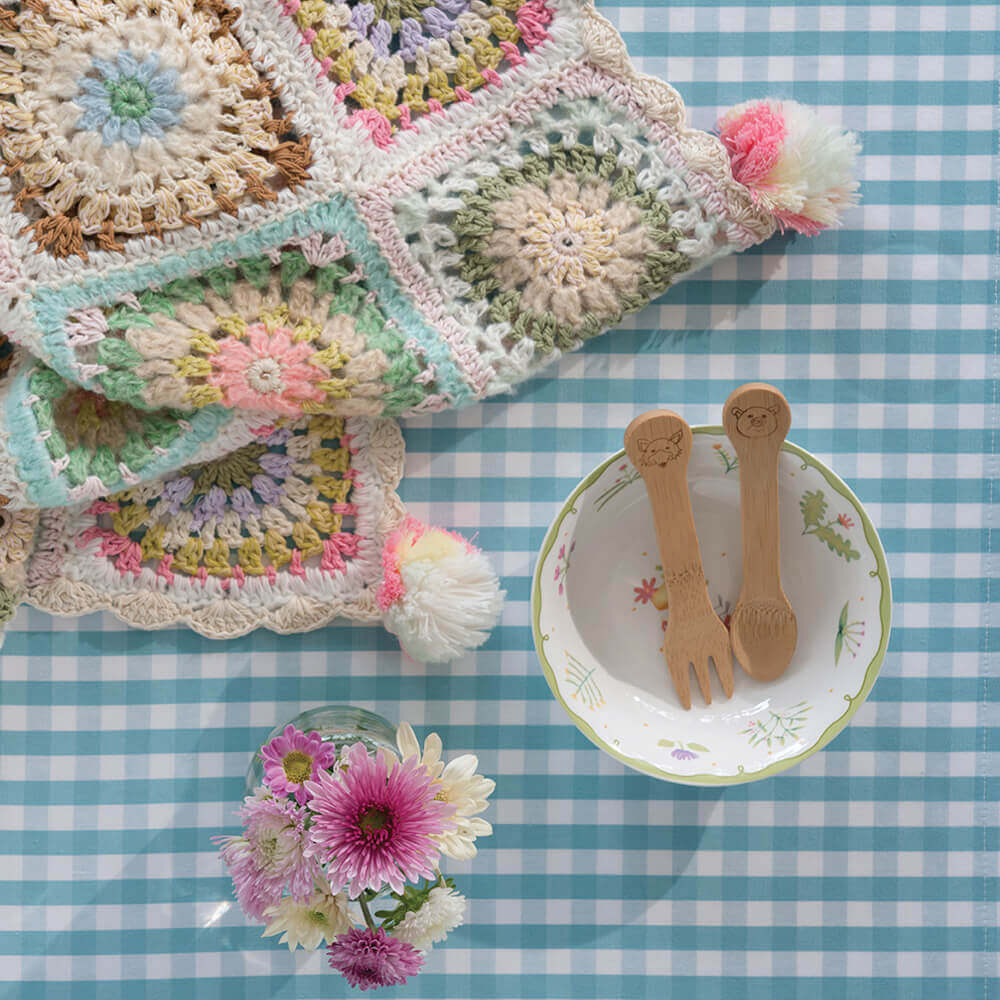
0,0,312,260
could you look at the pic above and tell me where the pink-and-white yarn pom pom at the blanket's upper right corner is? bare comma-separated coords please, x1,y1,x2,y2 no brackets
716,100,861,236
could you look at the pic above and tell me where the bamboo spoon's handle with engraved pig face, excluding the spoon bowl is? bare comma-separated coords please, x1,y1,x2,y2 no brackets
722,382,792,601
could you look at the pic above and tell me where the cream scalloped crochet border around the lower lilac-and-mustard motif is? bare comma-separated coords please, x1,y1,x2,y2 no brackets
23,417,406,639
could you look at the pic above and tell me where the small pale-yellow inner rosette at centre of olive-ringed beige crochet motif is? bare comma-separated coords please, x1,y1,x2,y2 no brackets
517,201,618,288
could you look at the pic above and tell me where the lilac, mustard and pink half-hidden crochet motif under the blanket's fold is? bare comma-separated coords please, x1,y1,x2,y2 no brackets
77,417,358,587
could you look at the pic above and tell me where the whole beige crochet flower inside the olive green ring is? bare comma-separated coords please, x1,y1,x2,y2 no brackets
485,176,657,326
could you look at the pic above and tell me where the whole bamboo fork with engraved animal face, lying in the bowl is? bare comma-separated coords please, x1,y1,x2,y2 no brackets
625,410,733,709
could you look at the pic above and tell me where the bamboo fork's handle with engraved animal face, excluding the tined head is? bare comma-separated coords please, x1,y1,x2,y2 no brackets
625,410,715,614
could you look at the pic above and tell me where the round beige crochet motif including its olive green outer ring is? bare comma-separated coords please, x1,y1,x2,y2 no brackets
452,144,690,353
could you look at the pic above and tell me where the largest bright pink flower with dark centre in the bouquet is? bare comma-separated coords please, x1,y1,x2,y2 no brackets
306,743,455,898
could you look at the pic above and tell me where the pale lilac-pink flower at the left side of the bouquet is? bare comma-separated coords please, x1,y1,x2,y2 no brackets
212,790,323,920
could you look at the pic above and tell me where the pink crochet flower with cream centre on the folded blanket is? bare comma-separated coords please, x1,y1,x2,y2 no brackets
207,323,326,417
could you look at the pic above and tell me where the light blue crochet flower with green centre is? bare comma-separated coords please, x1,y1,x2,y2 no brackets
74,49,187,149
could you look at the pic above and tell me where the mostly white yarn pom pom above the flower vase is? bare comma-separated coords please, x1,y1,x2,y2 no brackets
378,517,504,663
